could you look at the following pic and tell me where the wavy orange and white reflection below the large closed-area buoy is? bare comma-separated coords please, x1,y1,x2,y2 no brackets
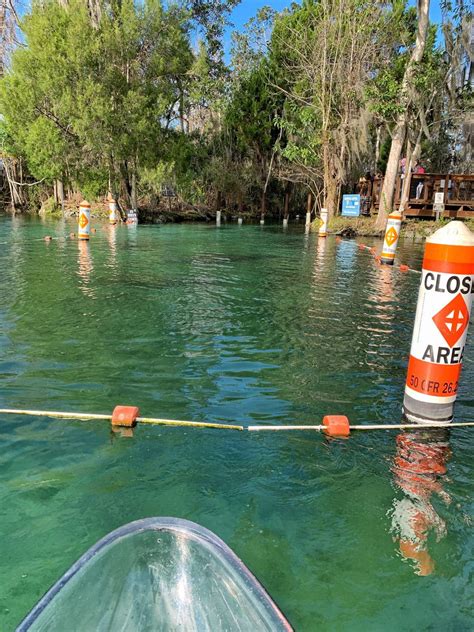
392,429,451,575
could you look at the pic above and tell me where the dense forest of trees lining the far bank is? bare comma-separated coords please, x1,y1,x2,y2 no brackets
0,0,473,222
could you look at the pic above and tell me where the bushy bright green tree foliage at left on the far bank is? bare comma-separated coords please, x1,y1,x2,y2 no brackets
0,0,192,198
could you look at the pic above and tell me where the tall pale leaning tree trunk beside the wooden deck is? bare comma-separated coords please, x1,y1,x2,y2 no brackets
375,0,430,229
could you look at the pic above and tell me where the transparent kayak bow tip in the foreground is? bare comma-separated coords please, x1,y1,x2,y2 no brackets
17,518,292,632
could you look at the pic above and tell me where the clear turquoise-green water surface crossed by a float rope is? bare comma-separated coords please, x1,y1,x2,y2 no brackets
0,217,474,631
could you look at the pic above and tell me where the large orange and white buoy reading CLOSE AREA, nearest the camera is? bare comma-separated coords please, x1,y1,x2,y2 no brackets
403,221,474,423
